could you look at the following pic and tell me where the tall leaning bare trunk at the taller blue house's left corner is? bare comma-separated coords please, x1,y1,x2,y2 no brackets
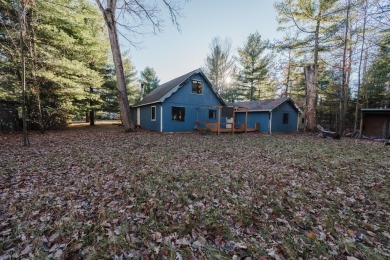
96,0,134,132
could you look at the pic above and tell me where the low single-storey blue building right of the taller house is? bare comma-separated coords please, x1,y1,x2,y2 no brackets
229,98,300,133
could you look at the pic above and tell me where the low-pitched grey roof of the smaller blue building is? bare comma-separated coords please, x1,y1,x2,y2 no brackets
228,97,301,113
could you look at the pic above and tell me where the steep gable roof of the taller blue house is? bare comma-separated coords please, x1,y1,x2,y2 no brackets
134,69,226,107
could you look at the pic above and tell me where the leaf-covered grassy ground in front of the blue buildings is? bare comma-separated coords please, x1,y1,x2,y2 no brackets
0,125,390,259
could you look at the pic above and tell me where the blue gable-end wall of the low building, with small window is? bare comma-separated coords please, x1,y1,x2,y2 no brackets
271,102,298,133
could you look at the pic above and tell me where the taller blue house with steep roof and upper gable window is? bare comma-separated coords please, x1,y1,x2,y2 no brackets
131,69,226,132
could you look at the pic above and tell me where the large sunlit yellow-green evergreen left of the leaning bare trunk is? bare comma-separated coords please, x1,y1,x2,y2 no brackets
33,0,108,129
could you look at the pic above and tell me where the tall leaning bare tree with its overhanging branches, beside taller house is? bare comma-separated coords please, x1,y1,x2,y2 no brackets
95,0,184,131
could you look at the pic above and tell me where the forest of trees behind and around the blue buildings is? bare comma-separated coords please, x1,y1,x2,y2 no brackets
0,0,390,133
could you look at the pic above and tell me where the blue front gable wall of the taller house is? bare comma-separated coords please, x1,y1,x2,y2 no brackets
161,74,223,132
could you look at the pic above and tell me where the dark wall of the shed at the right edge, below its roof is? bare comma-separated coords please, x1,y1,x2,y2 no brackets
362,114,390,138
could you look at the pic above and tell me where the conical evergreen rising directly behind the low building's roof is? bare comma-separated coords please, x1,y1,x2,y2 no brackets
237,32,269,100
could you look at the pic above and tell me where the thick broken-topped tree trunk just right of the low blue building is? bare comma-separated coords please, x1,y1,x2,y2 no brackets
304,65,318,131
